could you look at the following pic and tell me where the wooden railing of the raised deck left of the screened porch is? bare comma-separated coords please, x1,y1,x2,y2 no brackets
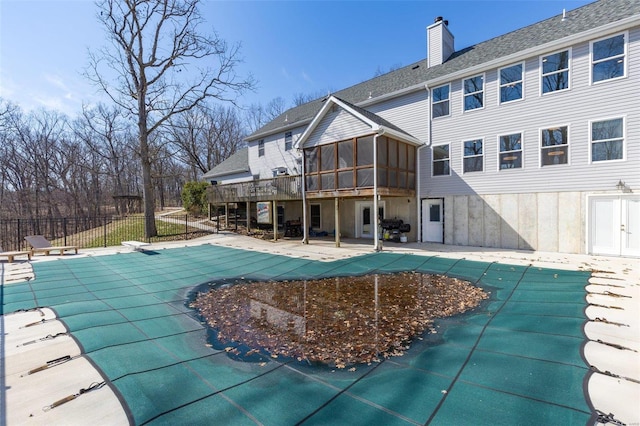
207,175,302,204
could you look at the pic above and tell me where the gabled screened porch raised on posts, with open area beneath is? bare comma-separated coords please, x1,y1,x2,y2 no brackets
299,96,421,249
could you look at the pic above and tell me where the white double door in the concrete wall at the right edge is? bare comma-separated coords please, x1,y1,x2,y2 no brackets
589,195,640,257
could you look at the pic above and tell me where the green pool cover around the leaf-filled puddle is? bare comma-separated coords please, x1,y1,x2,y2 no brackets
1,245,592,425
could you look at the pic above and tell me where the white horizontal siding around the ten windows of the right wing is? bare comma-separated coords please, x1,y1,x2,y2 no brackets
420,28,640,197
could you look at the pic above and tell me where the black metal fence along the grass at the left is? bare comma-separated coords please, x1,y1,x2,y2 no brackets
0,214,216,251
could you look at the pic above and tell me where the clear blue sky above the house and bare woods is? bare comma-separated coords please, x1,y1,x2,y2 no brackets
0,0,590,116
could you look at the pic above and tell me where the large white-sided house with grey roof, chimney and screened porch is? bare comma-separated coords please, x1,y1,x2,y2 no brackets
205,0,640,256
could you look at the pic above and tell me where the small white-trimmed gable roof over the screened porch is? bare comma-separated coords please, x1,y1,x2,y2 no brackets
298,96,421,147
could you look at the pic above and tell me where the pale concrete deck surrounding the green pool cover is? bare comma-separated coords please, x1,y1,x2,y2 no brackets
0,233,640,425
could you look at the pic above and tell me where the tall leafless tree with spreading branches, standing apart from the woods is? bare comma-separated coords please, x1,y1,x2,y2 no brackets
86,0,254,238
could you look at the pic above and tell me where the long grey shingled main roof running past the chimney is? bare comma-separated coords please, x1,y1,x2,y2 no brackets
247,0,640,140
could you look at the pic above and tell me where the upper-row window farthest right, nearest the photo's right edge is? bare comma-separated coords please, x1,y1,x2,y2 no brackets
591,34,625,83
